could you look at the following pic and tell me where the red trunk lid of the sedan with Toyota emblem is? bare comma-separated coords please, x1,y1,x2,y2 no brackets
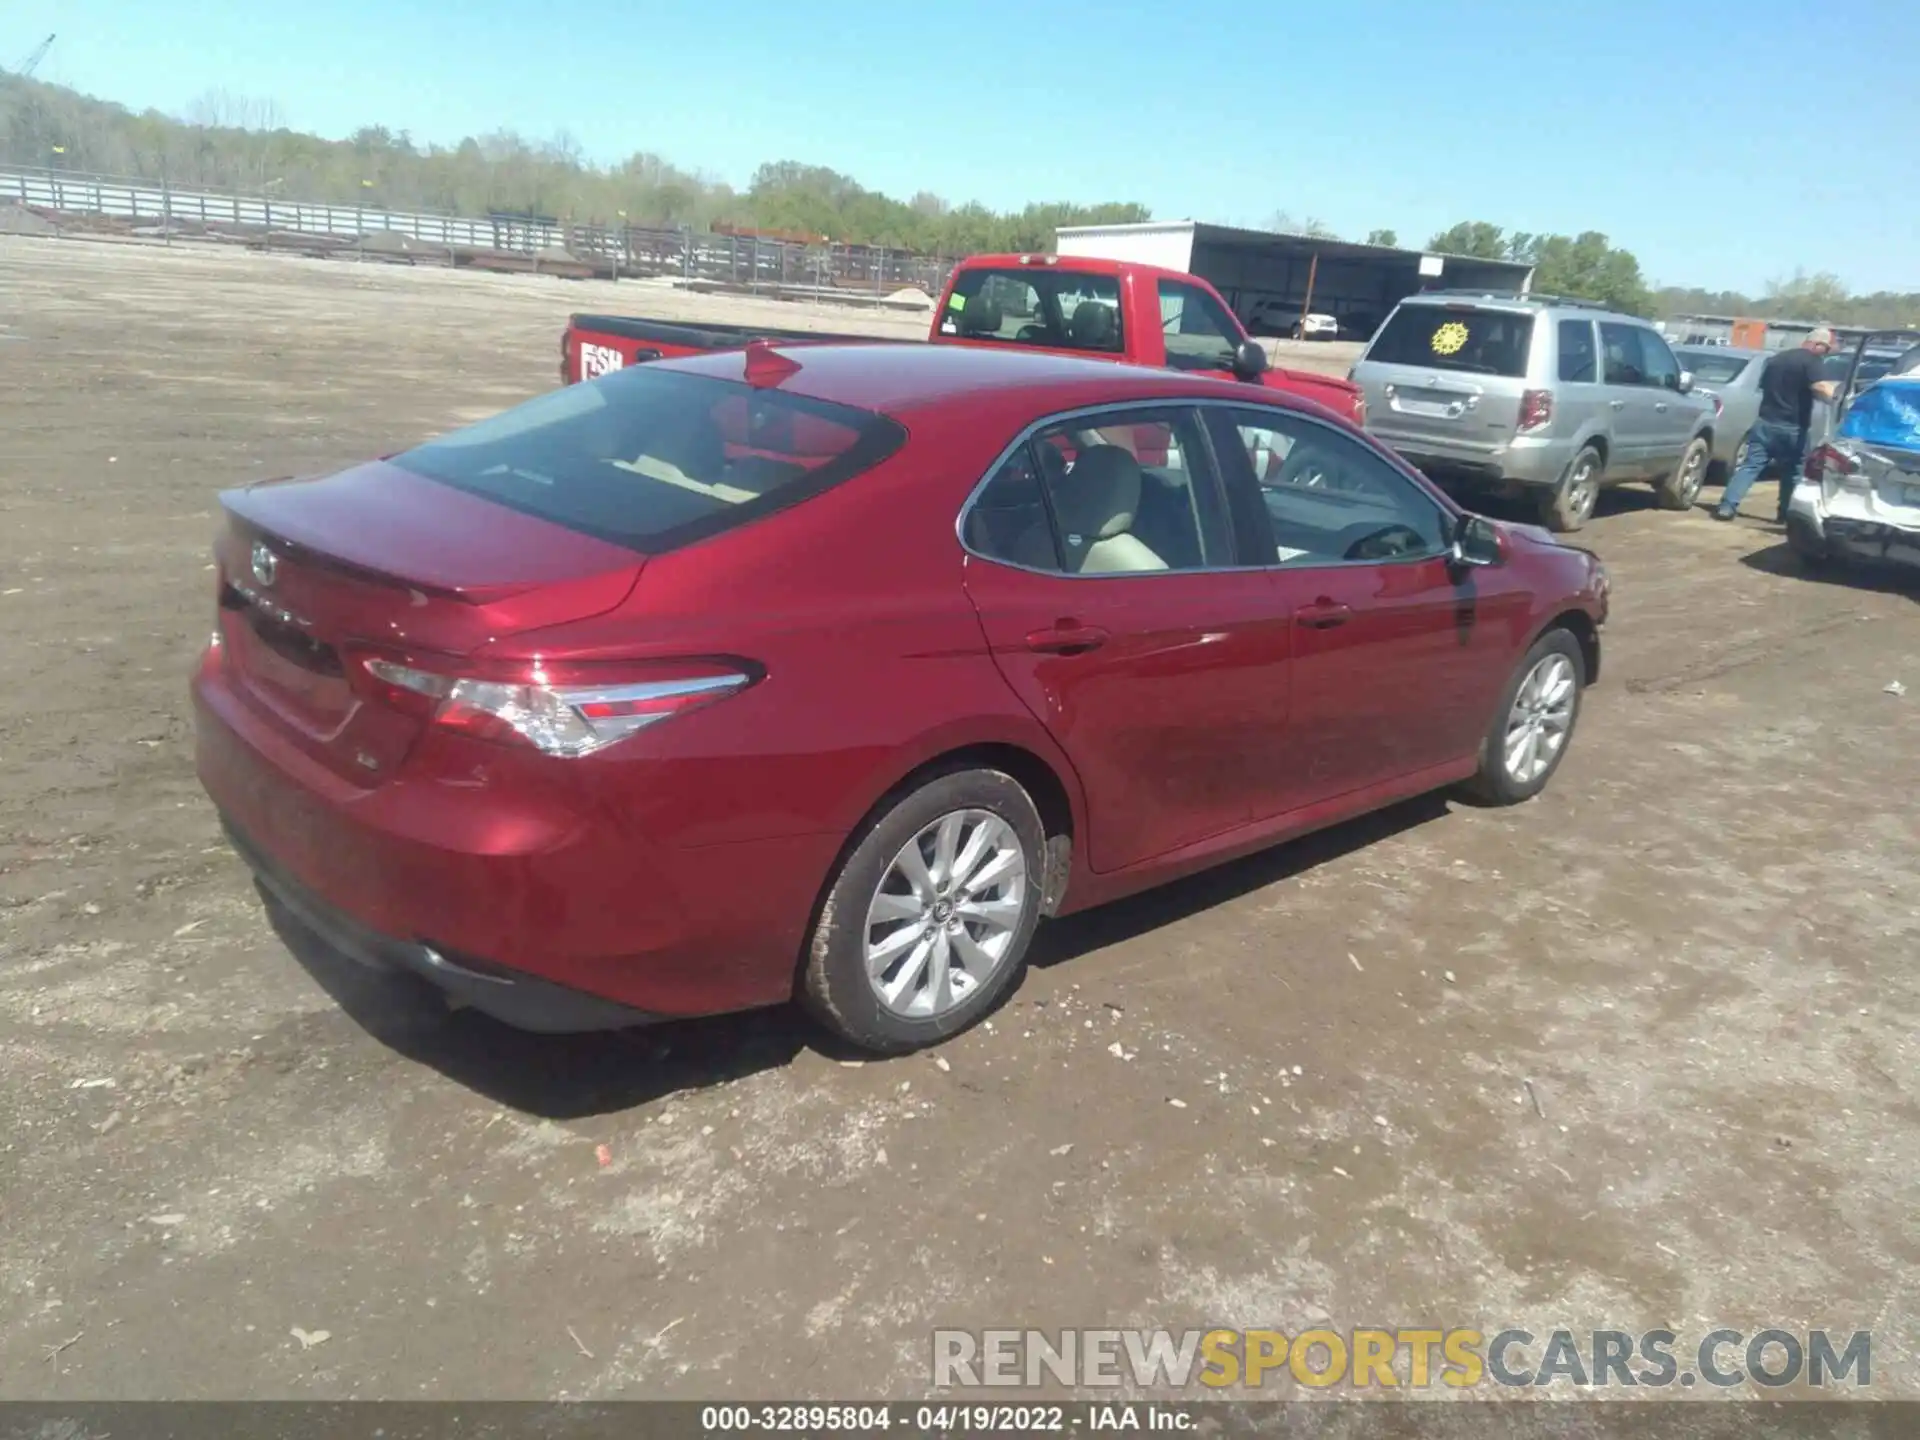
215,461,645,785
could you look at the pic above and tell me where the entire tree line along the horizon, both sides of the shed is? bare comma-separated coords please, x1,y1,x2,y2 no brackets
0,75,1920,326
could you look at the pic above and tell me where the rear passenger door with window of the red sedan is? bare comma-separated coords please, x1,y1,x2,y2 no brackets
962,407,1292,872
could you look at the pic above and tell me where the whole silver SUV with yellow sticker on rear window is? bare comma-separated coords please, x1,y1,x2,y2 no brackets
1352,290,1715,532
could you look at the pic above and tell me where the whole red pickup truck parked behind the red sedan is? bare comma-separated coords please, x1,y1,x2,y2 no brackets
561,255,1367,424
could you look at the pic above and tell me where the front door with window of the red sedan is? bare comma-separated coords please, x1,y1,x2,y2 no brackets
1212,407,1526,804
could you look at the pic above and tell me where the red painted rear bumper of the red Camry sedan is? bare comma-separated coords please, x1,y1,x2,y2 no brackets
192,660,837,1029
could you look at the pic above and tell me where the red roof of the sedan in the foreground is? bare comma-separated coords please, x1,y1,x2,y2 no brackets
651,340,1308,419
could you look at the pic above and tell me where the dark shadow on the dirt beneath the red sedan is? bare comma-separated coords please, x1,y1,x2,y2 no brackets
263,793,1448,1119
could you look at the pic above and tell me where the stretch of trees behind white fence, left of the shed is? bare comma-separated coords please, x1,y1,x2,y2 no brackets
0,75,1152,255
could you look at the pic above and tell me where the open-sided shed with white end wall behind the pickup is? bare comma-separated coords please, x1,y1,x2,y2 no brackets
1054,221,1534,334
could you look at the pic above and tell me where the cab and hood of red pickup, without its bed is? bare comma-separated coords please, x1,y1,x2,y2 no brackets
927,255,1367,424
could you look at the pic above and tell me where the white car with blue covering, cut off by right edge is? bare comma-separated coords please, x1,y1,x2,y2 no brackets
1788,332,1920,568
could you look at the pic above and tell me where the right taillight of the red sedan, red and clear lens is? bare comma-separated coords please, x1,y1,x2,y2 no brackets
353,653,755,758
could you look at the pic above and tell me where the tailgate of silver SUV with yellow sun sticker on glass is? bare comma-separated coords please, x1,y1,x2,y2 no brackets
1354,303,1534,461
